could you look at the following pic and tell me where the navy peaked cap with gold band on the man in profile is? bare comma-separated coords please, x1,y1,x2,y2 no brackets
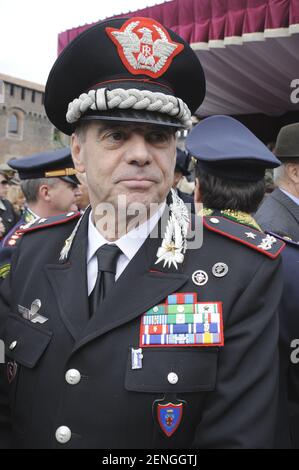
8,147,79,185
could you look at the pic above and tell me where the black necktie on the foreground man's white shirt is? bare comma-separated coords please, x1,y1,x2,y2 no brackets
89,245,121,315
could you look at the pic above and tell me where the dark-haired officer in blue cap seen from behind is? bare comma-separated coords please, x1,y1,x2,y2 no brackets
186,116,299,448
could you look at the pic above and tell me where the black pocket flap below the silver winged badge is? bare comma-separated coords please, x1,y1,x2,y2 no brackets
5,314,52,369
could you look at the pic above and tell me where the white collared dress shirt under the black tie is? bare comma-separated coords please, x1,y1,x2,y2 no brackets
87,202,166,295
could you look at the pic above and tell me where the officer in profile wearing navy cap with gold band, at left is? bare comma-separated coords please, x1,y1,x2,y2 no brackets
0,147,81,279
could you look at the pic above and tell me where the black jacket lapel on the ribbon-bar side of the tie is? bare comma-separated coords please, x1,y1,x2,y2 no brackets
74,217,188,351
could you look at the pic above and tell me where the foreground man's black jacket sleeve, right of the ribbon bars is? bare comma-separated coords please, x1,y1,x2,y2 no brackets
193,259,282,448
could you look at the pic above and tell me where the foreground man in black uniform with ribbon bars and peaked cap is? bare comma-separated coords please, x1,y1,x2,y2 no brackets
0,18,283,449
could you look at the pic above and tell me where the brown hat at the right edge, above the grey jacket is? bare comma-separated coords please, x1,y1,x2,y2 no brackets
274,122,299,163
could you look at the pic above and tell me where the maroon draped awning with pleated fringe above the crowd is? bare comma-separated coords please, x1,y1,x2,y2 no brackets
58,0,299,116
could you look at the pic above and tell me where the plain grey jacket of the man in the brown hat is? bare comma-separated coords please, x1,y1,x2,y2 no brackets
255,188,299,241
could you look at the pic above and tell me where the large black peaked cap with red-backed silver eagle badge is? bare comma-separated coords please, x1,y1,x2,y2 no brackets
45,17,205,135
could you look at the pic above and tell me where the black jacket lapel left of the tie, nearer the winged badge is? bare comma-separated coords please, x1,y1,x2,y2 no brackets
45,210,90,340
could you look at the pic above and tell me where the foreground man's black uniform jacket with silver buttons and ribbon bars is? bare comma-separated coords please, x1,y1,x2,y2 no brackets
0,207,282,449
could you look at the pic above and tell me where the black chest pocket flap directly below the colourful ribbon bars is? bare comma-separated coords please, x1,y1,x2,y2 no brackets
125,347,218,394
